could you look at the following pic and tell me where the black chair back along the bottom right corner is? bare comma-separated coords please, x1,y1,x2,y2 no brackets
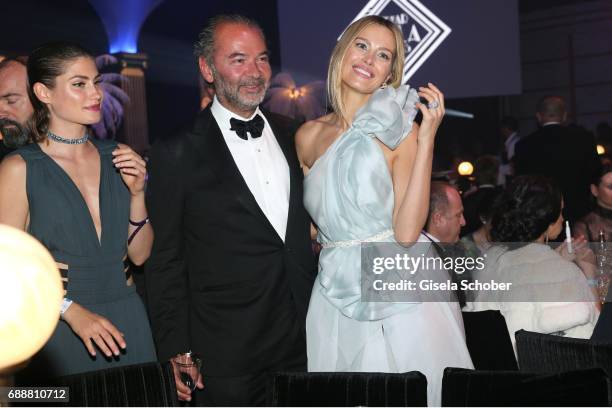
442,368,608,407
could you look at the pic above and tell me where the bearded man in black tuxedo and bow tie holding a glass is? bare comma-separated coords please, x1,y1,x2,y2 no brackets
146,16,316,405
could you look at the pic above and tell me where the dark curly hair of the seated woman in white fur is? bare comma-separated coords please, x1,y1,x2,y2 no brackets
490,176,562,243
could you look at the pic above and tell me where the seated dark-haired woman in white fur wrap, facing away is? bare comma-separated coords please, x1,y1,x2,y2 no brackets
464,176,599,352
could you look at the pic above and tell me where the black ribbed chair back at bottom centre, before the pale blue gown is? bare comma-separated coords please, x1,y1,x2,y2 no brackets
268,371,427,407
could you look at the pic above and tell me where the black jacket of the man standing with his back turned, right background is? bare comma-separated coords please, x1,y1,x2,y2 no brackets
513,125,599,221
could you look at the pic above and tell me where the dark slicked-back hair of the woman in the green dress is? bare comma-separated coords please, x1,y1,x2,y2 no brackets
27,42,94,143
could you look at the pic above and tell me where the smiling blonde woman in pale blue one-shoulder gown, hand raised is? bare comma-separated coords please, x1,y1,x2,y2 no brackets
296,16,473,405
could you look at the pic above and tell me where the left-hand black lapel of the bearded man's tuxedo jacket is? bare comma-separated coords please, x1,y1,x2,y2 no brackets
196,108,280,239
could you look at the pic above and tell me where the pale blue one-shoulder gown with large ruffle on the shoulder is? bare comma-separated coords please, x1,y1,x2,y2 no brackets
304,86,473,405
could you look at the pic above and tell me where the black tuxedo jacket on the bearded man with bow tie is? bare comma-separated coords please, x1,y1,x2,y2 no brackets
146,108,316,376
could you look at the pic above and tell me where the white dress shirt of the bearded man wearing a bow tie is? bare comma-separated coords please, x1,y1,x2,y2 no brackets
210,96,289,241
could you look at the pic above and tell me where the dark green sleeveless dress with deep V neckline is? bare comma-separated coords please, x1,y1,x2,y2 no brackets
14,140,156,377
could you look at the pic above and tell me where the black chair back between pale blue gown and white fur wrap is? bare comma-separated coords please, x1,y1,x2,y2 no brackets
462,310,518,370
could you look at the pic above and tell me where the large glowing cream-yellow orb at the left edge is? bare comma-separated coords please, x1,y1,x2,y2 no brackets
0,225,64,370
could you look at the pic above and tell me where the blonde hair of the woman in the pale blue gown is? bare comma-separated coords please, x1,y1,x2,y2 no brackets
327,16,406,124
